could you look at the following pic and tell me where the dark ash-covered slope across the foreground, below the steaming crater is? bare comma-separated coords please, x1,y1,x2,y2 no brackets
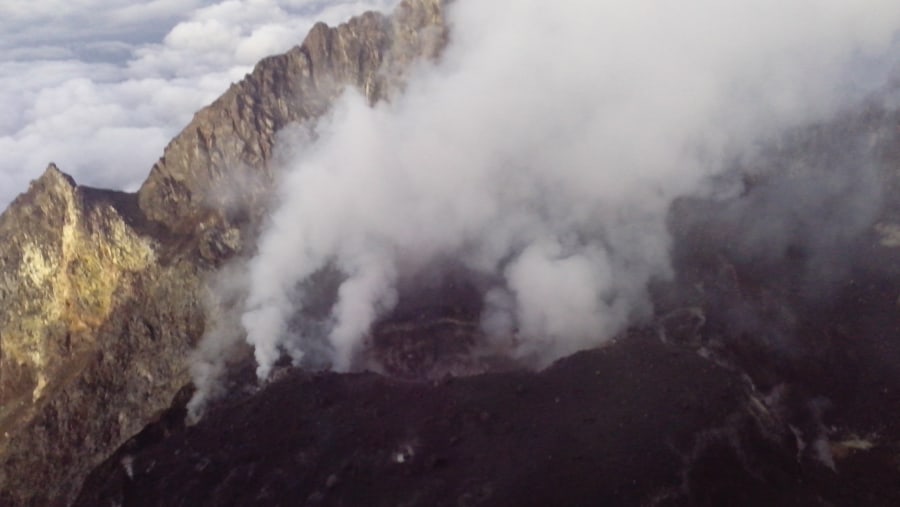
75,278,900,507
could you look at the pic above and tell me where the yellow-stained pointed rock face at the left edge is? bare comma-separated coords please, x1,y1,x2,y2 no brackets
0,165,203,505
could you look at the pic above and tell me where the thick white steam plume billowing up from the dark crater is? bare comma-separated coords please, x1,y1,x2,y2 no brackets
242,0,900,377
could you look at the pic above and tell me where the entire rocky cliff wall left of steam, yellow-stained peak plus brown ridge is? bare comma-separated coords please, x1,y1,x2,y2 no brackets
0,0,445,506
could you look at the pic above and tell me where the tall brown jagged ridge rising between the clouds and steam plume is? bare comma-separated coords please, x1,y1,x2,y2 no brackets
139,0,446,244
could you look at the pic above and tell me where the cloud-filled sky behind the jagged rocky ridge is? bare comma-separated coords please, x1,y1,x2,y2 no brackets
0,0,397,209
